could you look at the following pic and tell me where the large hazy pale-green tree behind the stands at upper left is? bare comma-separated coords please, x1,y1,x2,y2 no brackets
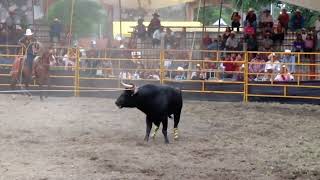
48,0,106,37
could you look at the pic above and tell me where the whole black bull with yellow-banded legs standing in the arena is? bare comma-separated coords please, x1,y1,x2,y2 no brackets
115,83,183,143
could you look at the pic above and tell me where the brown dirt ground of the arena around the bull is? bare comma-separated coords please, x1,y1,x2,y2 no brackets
0,95,320,180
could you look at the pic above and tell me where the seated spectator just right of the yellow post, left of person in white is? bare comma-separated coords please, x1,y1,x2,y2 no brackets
249,54,265,81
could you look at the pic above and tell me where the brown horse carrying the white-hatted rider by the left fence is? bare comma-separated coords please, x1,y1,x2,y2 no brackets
11,48,53,100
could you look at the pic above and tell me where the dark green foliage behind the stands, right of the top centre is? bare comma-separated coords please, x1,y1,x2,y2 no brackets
194,7,233,26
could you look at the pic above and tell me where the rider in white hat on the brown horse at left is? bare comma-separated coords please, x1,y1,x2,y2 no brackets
19,29,39,79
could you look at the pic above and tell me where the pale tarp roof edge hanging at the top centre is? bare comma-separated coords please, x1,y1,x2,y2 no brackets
104,0,194,9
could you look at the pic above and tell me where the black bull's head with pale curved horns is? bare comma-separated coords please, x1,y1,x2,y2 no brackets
116,81,138,108
